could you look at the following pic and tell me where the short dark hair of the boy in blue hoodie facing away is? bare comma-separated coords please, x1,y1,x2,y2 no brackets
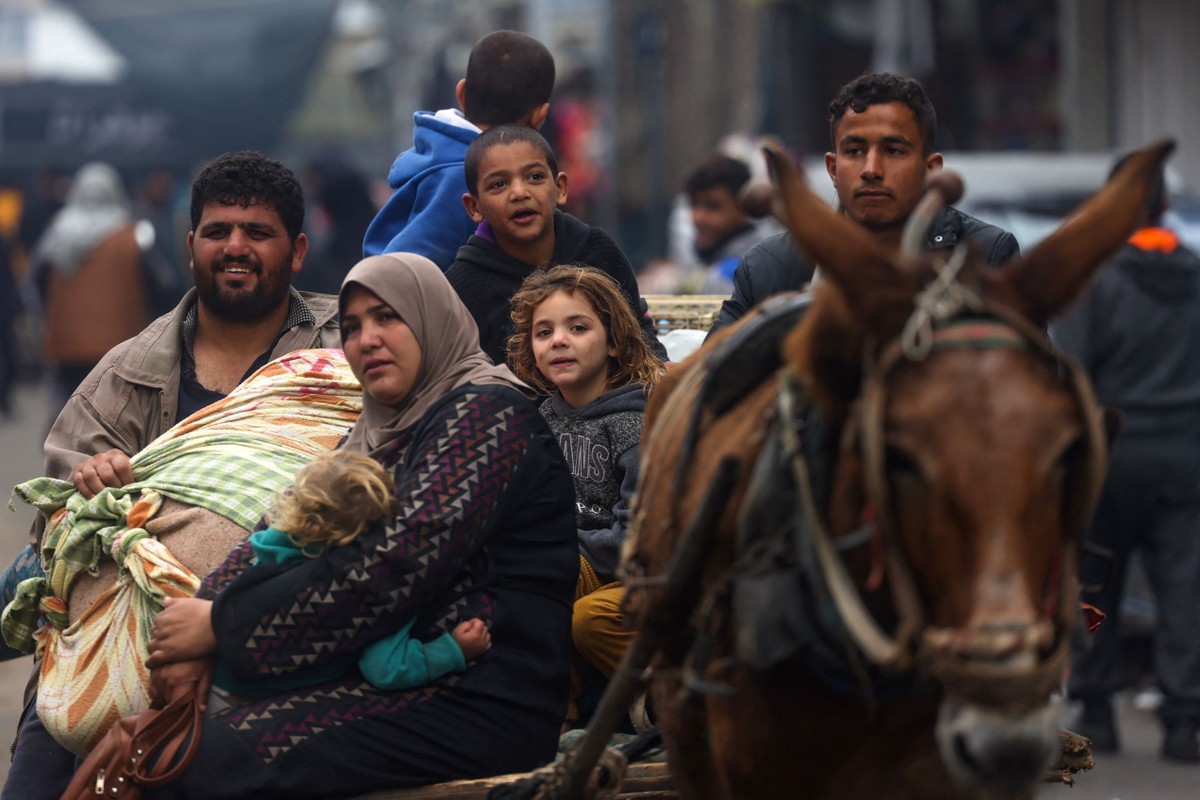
462,30,554,127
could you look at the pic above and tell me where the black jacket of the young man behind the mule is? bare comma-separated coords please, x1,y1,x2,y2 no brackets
708,206,1021,336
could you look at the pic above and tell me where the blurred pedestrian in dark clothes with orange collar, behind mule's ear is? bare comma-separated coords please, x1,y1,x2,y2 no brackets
1051,151,1200,763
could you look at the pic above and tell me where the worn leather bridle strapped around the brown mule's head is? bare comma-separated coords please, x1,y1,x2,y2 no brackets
778,248,1108,706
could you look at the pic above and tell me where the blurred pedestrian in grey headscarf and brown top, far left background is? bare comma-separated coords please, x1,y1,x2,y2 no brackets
32,162,148,415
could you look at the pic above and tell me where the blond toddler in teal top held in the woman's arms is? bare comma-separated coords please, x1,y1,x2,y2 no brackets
209,450,492,712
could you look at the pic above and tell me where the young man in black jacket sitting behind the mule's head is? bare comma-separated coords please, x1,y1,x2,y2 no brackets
709,73,1020,335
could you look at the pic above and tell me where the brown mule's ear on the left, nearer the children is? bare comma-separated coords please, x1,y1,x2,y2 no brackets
763,146,917,336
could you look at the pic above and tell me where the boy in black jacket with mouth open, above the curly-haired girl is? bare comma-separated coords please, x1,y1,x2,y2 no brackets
446,125,666,363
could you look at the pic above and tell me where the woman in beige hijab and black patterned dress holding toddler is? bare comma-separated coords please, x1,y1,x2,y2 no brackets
136,254,578,800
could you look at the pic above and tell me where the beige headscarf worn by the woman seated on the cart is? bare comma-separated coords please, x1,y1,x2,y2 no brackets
338,253,534,456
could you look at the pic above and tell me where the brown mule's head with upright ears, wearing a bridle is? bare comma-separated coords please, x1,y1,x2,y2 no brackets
768,143,1172,796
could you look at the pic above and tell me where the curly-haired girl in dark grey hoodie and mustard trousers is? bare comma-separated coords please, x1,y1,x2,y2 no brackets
509,265,662,729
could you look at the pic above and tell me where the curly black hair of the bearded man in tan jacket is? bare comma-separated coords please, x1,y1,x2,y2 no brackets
192,150,304,241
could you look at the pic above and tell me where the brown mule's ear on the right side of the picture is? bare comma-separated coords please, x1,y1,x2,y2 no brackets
994,139,1175,325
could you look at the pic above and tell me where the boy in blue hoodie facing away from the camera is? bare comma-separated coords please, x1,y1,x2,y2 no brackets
362,30,554,271
